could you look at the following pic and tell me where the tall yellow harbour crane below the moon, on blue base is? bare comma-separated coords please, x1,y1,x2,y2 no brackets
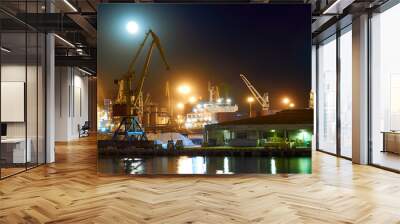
113,29,169,140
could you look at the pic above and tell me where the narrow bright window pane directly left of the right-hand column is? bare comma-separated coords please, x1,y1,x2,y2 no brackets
340,30,352,158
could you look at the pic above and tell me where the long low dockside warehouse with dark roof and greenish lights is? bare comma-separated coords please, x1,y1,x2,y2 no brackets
204,109,313,148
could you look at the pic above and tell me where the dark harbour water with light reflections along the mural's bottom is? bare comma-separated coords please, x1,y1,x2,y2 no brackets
98,156,311,174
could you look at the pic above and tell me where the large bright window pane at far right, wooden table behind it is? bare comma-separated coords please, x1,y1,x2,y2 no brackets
371,4,400,170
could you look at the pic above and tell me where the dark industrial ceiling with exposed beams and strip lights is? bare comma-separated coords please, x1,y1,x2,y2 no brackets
0,0,386,73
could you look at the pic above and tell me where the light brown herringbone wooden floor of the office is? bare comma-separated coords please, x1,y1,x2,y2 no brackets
0,139,400,224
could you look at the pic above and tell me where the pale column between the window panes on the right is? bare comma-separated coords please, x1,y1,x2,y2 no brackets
352,15,368,164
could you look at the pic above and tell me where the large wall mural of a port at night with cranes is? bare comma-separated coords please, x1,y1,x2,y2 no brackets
97,4,313,175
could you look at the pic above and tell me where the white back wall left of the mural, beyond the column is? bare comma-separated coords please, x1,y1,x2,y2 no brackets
55,67,89,141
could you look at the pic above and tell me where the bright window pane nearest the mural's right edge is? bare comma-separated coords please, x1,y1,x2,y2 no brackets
318,37,336,153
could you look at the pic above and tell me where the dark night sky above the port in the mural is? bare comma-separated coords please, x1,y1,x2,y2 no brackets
98,4,311,111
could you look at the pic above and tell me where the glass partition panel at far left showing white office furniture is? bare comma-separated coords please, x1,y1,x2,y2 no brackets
0,32,27,177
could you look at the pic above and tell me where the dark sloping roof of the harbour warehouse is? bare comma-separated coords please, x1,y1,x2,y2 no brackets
210,109,314,126
